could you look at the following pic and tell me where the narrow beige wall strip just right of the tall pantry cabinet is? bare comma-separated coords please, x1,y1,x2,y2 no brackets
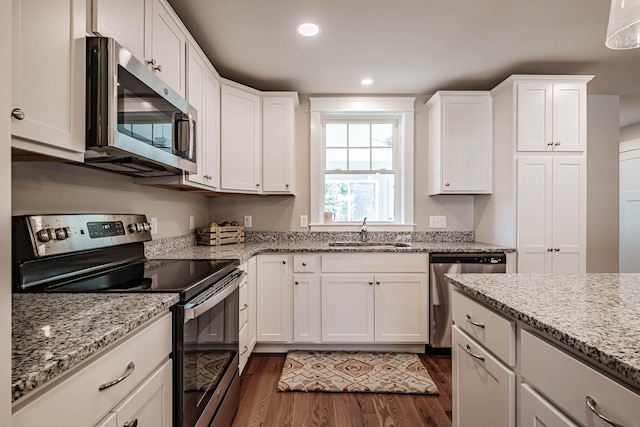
587,95,620,273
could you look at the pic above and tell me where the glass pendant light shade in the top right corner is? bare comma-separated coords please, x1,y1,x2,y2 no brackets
605,0,640,49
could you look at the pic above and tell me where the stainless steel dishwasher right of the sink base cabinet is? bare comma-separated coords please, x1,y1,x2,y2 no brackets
429,253,507,349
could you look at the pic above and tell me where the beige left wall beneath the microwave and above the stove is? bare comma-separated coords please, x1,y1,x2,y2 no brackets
11,163,209,239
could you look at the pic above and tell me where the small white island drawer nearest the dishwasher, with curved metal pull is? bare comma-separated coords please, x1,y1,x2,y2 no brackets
451,291,516,366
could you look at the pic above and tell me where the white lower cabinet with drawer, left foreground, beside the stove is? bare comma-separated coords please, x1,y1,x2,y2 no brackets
11,313,172,427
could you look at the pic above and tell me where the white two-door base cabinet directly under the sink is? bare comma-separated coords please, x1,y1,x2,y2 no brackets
322,254,429,344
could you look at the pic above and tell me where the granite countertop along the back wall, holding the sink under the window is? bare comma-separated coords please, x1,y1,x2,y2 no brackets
147,241,514,263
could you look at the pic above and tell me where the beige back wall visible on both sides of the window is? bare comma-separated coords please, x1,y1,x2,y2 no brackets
209,96,473,231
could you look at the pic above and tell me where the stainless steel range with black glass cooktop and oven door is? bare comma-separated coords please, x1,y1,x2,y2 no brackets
13,214,246,427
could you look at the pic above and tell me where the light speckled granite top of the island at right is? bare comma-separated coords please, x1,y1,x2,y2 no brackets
447,273,640,390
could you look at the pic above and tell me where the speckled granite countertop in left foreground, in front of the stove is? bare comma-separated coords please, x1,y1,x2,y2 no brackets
11,293,178,401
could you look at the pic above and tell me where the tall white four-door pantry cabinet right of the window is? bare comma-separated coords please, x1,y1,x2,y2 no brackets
475,75,593,273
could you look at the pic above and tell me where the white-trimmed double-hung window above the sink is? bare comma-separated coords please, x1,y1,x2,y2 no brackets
311,97,414,230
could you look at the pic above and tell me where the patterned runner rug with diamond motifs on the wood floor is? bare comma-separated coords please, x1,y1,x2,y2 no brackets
278,350,438,394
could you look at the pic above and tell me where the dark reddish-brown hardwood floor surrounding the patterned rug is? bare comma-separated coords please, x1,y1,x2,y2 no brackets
233,354,451,427
